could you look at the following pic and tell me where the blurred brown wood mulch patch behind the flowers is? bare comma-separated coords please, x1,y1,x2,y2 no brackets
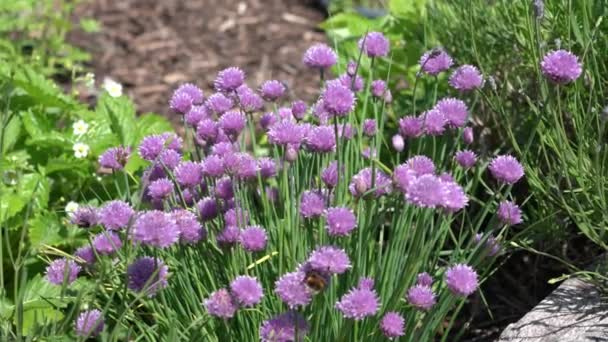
70,0,325,119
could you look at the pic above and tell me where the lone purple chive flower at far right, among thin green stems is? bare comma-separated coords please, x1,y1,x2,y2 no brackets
540,50,583,84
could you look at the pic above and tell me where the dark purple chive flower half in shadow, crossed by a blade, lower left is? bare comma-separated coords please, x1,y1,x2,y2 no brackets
127,257,169,297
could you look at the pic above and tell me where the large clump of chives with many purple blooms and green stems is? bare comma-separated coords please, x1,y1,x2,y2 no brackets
47,32,524,341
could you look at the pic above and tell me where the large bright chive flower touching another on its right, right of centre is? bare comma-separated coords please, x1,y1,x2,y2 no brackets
405,175,447,208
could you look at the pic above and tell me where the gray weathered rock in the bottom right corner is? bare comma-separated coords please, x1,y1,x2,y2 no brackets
498,278,608,342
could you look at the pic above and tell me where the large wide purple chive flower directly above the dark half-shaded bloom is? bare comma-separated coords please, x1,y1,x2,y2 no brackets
132,210,180,248
